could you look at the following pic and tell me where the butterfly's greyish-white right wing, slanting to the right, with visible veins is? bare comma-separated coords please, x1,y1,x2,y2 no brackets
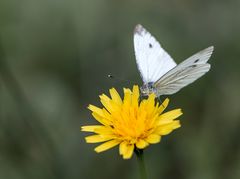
154,46,214,96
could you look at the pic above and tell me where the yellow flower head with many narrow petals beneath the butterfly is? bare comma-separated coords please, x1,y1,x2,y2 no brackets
81,86,182,159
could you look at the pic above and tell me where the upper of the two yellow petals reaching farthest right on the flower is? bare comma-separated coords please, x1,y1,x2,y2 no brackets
157,109,182,125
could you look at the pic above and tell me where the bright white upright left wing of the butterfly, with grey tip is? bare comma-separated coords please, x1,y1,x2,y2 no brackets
134,25,176,84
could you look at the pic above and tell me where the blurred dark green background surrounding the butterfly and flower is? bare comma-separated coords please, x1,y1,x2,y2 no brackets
0,0,240,179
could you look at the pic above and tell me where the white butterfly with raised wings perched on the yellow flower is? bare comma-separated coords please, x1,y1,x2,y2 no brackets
134,25,213,96
